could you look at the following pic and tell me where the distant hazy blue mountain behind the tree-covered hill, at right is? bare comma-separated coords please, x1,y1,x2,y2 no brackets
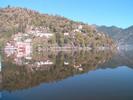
96,26,133,45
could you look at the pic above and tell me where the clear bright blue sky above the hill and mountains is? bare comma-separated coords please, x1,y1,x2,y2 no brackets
0,0,133,28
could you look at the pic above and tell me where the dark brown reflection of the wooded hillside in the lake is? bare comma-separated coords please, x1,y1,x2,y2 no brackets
2,51,112,90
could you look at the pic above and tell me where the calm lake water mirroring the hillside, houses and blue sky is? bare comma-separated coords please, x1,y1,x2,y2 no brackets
0,51,133,100
